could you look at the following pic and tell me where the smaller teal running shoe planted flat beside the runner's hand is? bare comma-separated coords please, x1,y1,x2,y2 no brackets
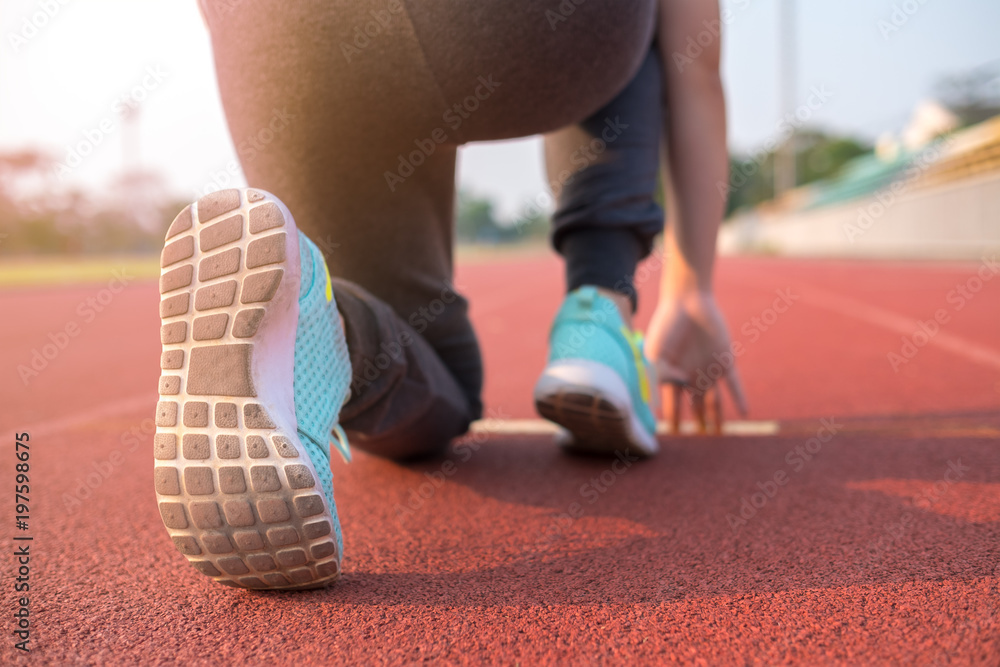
535,287,659,456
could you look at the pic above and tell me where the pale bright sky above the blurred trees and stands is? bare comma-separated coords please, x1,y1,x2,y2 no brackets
0,0,1000,218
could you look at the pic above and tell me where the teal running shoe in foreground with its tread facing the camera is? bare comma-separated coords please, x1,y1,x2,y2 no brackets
153,189,351,589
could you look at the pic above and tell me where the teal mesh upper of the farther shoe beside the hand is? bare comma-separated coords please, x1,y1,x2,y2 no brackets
549,287,656,433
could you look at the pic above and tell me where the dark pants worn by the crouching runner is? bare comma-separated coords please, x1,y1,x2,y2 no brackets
197,0,663,457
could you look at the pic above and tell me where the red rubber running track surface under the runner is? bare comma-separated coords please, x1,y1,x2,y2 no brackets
0,258,1000,665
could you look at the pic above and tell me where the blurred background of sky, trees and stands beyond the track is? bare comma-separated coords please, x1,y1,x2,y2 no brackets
0,0,1000,266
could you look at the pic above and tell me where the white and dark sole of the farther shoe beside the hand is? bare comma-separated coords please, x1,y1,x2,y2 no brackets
534,359,660,456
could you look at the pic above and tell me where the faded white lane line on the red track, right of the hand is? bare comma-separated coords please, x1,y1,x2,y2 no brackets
795,285,1000,369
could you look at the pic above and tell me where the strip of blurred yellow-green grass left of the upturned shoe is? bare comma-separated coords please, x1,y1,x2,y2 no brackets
0,255,160,288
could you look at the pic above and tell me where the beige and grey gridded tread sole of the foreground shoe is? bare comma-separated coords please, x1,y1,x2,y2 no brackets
153,190,340,589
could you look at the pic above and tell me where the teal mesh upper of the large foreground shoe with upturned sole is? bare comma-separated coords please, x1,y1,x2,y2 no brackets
295,232,351,553
